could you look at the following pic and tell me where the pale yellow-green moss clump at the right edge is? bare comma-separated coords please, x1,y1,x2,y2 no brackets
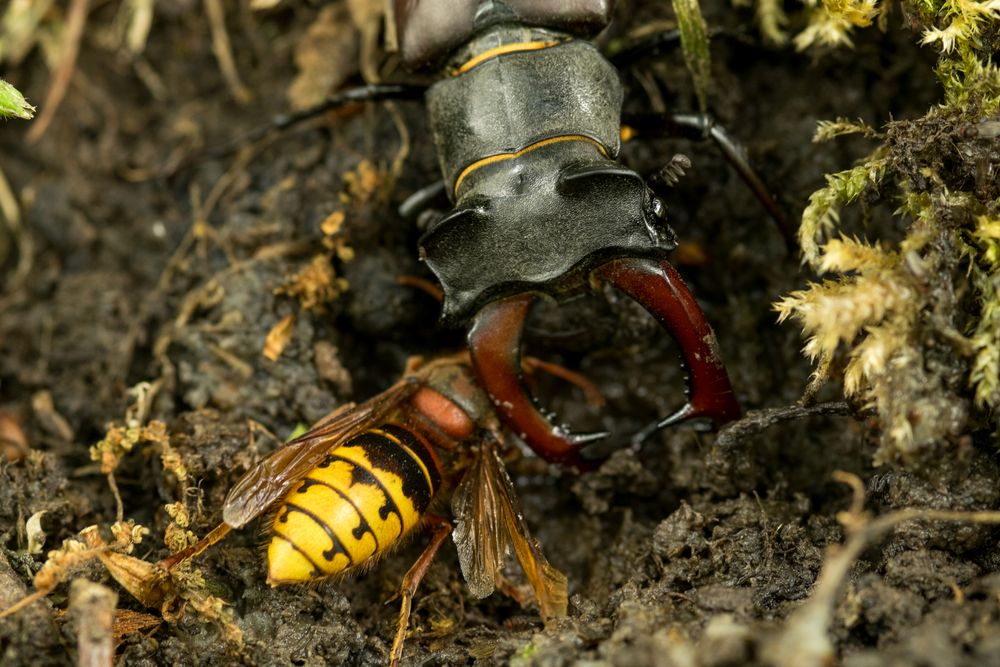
776,0,1000,462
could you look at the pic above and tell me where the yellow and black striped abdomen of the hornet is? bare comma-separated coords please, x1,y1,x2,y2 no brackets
267,424,441,586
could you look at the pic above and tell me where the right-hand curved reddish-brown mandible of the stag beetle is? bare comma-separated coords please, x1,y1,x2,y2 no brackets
594,258,740,433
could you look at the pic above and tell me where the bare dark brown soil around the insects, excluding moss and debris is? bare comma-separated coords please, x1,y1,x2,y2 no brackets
0,0,1000,667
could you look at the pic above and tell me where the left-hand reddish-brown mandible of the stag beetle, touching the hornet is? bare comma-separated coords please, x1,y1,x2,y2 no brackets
469,294,607,469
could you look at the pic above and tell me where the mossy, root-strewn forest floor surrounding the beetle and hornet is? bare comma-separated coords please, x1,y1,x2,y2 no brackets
0,0,1000,667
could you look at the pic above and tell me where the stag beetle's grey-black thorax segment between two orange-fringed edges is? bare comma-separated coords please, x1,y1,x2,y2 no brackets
427,25,622,199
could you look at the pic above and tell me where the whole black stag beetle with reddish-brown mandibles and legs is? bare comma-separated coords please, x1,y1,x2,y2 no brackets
236,0,789,469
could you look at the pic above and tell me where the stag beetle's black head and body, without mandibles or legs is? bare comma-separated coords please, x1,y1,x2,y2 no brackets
396,0,676,324
